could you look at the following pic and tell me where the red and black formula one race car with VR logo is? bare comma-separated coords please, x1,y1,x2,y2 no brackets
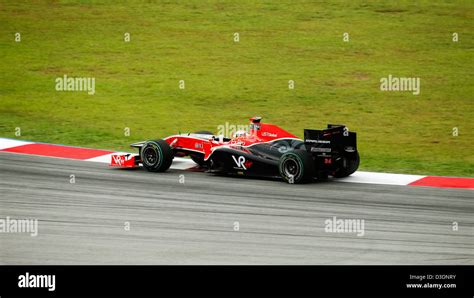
111,117,359,183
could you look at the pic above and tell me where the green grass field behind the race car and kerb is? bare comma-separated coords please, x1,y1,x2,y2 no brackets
0,0,474,176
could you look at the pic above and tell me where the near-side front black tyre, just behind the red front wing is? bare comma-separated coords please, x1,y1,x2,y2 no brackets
140,140,173,172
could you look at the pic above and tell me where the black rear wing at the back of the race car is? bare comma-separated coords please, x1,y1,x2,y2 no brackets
304,124,357,155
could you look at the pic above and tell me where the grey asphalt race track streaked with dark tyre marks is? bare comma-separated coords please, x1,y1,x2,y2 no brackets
0,152,474,265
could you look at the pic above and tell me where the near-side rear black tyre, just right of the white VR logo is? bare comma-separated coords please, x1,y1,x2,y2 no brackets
278,150,314,183
